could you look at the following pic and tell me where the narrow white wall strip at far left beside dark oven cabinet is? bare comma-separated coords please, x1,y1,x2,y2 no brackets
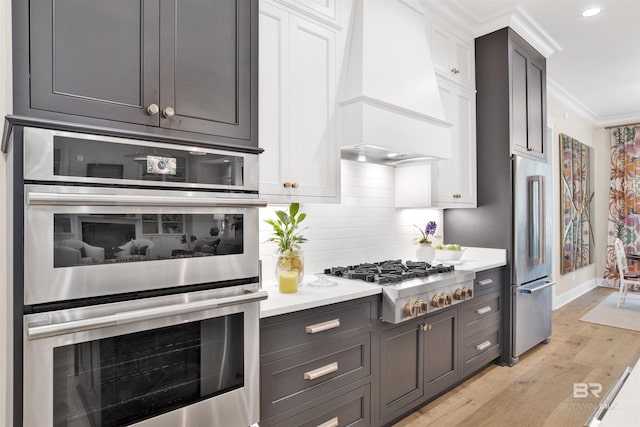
0,0,12,426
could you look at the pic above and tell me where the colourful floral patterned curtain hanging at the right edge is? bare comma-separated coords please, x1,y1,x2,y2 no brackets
604,124,640,286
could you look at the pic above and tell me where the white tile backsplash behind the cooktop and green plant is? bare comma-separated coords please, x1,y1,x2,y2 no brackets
260,160,444,281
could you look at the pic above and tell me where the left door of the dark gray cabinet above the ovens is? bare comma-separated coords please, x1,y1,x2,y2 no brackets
29,0,159,126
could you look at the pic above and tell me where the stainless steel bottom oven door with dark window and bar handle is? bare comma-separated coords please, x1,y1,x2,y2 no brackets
23,289,266,427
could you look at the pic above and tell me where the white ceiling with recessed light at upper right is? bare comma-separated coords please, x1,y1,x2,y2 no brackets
440,0,640,125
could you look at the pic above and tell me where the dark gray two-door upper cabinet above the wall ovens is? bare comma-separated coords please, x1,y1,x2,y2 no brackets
14,0,258,147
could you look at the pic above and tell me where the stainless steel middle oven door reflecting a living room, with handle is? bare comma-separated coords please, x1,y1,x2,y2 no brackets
24,185,265,305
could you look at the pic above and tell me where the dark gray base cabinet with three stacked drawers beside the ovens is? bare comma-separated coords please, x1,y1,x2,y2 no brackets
260,296,380,427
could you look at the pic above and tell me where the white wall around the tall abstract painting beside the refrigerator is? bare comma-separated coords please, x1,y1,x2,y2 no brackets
547,93,609,305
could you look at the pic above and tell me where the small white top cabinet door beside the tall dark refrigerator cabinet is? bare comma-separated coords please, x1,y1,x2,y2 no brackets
429,17,475,88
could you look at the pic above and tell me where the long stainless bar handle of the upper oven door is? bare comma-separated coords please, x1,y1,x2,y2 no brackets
27,191,267,208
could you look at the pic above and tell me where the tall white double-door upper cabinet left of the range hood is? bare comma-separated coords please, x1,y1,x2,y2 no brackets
259,1,340,203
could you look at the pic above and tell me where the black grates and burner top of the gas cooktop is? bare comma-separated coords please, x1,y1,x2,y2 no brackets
324,259,454,285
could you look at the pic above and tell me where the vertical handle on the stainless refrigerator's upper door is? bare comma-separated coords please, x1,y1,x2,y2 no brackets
527,175,546,264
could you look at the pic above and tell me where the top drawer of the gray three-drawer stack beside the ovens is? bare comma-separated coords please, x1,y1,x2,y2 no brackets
260,298,377,356
